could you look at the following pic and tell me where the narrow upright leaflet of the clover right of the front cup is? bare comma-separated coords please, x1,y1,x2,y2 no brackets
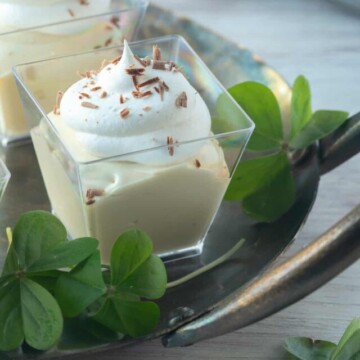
290,75,312,139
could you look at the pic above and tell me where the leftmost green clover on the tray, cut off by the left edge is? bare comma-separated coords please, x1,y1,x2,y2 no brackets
0,211,98,351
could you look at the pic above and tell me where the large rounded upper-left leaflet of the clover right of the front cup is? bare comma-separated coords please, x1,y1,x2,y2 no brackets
228,81,283,151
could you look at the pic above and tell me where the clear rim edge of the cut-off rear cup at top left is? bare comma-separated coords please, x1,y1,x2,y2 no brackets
0,0,150,37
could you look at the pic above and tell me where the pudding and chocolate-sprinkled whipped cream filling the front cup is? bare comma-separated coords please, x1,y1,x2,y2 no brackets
31,42,229,263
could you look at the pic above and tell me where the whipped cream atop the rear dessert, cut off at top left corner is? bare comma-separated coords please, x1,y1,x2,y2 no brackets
0,0,111,35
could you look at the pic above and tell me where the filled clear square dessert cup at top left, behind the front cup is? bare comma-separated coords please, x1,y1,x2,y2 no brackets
0,0,148,146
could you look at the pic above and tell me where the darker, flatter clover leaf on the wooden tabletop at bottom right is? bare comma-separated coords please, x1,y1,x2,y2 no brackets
284,337,336,360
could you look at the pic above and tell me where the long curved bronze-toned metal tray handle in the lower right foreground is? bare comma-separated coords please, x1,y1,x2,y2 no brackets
162,202,360,347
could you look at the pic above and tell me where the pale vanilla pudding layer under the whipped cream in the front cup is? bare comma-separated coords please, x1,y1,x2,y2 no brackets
31,119,229,264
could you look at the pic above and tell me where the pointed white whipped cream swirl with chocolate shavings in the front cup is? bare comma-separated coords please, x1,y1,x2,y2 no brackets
59,42,211,165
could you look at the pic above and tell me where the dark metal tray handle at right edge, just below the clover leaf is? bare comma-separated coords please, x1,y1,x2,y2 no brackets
319,112,360,175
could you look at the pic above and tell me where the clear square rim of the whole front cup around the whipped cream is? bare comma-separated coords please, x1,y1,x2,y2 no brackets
12,34,255,165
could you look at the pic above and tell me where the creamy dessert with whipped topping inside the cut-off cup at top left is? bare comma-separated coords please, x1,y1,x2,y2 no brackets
0,0,123,138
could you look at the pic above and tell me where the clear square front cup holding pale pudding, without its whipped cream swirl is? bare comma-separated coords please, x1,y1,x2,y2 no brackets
14,35,254,264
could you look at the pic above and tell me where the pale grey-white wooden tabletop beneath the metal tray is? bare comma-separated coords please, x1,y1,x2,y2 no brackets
98,0,360,360
